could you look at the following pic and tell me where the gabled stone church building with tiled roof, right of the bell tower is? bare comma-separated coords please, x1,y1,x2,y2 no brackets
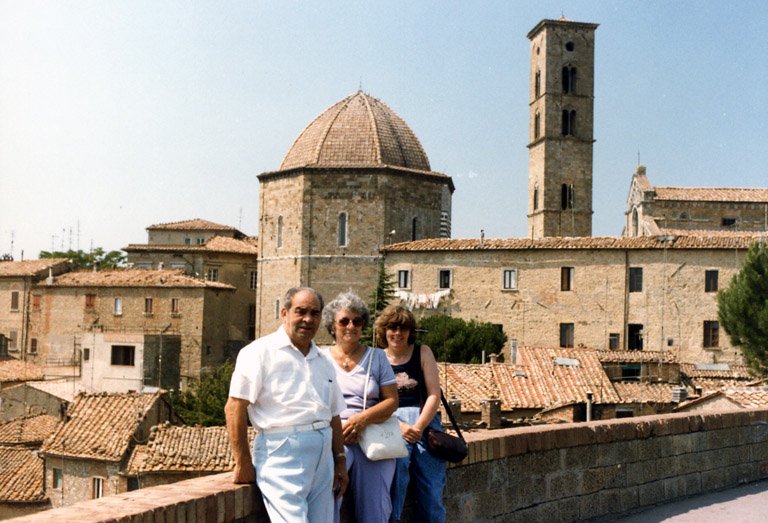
624,165,768,236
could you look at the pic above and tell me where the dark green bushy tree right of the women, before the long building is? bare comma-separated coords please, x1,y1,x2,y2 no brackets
418,316,507,363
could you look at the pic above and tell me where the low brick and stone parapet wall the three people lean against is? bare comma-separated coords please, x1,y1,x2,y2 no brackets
15,409,768,523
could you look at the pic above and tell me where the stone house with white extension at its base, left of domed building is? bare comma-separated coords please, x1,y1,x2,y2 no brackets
28,269,235,392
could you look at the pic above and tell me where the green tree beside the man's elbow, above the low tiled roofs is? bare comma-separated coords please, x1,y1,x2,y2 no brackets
170,361,235,427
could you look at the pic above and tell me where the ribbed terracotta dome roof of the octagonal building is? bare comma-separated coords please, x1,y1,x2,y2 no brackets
280,91,430,171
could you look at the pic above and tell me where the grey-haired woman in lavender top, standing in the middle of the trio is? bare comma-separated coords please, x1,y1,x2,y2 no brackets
323,292,398,523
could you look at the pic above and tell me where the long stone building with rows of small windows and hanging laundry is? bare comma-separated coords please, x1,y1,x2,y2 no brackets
385,238,750,362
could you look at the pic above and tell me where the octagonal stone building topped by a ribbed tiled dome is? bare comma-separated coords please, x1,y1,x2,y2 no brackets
256,91,454,335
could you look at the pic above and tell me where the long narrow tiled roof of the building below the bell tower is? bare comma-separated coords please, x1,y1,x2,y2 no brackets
382,236,759,252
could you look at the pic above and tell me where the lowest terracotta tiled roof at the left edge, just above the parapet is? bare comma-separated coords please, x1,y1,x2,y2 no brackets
0,446,46,503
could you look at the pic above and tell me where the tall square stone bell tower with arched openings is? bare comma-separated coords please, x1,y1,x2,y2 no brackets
528,18,598,238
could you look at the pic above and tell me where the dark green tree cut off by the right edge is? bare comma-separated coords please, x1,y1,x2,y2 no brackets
717,242,768,375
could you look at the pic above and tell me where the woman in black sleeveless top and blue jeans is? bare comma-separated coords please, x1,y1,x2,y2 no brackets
375,305,446,523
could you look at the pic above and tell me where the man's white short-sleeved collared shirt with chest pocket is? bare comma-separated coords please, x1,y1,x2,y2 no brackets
229,326,346,430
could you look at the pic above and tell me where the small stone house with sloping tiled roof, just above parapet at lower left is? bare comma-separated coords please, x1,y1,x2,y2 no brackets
40,393,174,507
